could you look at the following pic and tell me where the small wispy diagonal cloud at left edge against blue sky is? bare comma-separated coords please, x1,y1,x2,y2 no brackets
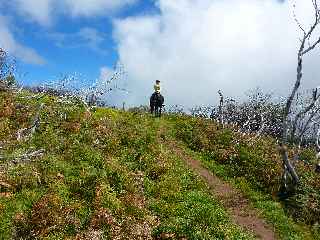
0,16,45,65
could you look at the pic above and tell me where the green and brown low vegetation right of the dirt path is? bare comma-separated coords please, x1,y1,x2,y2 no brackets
168,115,320,239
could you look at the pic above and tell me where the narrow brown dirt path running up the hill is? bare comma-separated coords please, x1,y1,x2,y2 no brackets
158,123,277,240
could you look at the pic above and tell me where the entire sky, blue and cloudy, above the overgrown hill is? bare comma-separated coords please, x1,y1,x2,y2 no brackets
0,0,320,107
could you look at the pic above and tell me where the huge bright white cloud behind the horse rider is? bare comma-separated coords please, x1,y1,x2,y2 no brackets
114,0,320,106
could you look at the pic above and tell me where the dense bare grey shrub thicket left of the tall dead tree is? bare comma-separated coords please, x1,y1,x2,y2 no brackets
210,88,283,138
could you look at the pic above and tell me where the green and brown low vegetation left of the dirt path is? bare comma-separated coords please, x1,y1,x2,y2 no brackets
0,92,253,239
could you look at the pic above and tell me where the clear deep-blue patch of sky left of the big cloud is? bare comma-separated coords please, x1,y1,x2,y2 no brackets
0,0,157,85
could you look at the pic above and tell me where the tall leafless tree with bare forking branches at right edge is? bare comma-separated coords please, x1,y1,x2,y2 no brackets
280,0,320,189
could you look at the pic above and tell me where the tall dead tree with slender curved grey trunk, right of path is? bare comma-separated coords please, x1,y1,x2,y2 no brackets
280,0,320,189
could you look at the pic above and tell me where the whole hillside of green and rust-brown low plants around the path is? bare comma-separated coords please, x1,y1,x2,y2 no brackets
0,92,320,239
